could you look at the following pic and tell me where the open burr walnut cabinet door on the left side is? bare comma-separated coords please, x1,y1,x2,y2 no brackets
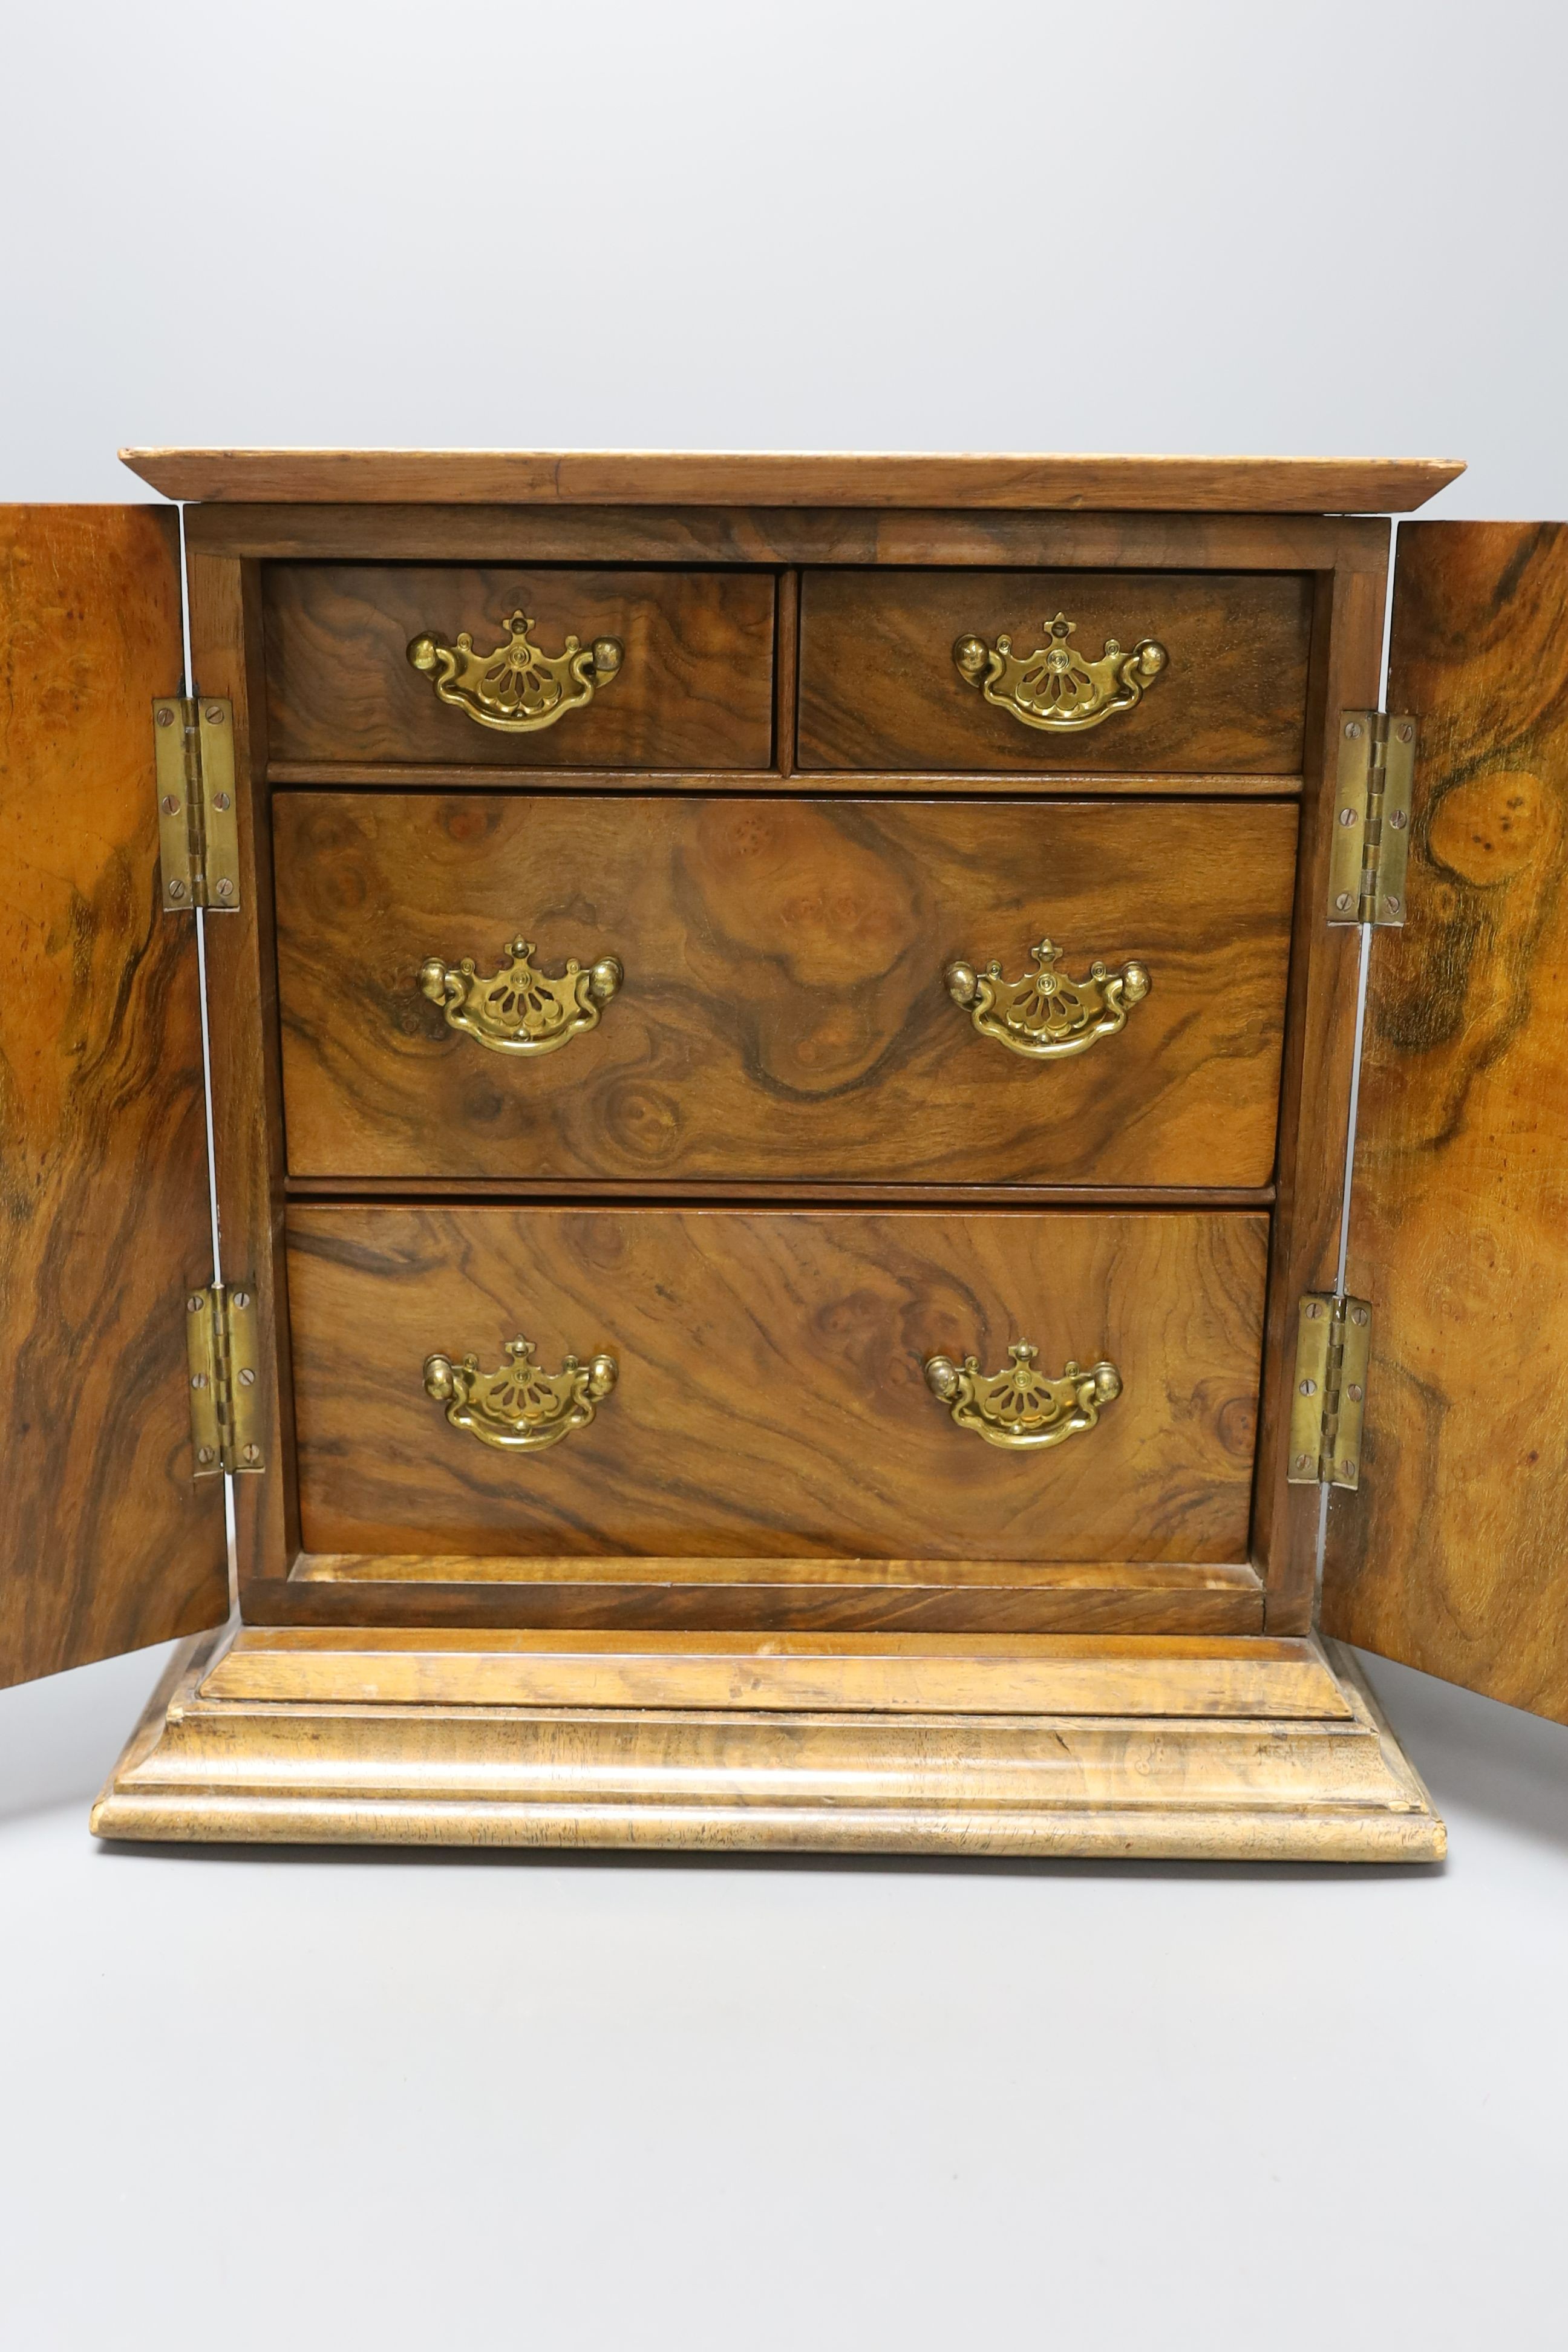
0,506,228,1684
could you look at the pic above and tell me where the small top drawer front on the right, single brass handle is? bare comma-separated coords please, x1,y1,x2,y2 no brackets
799,572,1312,776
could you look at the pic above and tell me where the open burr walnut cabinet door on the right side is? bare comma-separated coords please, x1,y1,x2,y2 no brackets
1324,522,1568,1722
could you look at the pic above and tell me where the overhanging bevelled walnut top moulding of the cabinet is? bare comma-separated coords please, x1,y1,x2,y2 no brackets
120,449,1465,515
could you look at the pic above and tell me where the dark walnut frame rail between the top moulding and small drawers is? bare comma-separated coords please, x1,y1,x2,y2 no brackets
186,503,1387,572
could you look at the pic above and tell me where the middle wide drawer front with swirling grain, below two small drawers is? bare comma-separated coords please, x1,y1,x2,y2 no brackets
273,792,1298,1186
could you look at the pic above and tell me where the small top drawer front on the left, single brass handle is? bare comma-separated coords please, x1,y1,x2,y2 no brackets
263,564,774,769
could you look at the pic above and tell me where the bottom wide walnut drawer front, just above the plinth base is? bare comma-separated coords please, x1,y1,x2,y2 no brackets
289,1204,1267,1562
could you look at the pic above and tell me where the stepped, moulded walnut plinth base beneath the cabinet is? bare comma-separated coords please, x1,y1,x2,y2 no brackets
92,1627,1446,1863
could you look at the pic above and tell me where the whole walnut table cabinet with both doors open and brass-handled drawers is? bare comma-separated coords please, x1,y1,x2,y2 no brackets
0,449,1568,1860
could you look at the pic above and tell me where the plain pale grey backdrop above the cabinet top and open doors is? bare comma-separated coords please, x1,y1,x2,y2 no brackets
0,0,1568,517
